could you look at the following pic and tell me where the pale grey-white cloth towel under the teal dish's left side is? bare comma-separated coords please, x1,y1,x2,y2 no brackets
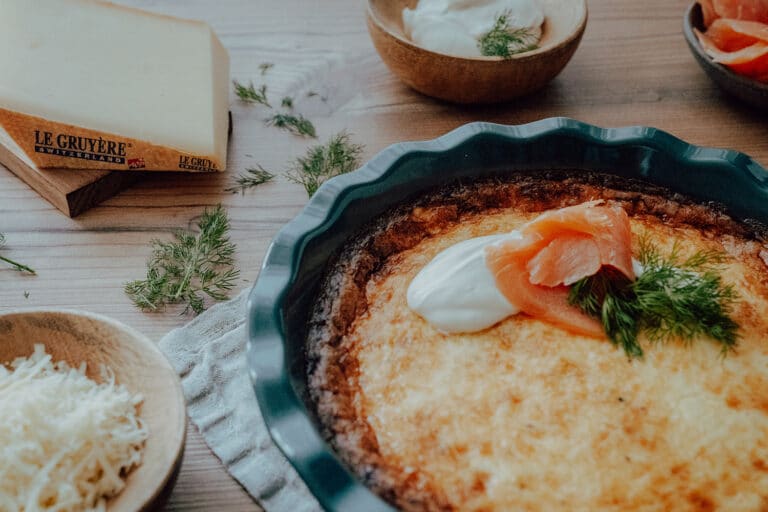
160,291,322,512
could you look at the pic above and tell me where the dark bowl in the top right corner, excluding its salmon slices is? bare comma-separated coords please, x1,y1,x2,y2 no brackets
683,2,768,110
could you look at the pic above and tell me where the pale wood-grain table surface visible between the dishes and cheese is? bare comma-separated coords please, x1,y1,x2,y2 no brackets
0,0,768,511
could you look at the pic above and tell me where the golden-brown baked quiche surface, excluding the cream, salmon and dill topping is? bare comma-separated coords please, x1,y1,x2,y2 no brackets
307,171,768,512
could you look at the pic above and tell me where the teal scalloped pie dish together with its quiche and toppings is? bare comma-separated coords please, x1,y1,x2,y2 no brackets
248,118,768,511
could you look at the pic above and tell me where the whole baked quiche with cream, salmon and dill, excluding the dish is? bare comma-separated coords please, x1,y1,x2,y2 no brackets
307,172,768,512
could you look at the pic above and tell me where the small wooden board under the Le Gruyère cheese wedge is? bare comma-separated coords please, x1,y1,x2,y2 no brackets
0,129,141,217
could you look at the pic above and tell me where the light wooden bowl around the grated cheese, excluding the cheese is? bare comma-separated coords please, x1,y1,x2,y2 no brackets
0,311,186,512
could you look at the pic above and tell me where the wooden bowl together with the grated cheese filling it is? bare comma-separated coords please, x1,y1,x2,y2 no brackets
0,310,186,512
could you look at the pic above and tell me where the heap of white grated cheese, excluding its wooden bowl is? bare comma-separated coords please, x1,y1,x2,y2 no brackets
0,344,148,512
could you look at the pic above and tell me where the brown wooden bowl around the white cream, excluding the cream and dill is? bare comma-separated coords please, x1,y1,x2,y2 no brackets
367,0,587,103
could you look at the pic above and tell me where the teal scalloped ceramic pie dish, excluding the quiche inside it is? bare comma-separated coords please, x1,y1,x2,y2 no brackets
247,118,768,512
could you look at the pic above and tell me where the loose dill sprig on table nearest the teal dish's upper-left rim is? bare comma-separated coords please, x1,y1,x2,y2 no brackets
285,132,363,197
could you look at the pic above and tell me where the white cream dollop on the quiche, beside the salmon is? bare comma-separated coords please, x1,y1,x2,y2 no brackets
407,231,520,333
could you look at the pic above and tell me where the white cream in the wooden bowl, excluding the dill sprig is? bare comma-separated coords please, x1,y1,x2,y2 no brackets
403,0,544,57
